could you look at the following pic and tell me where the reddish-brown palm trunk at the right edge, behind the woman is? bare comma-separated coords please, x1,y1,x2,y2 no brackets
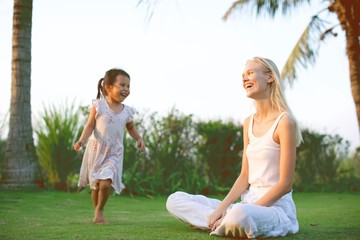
331,0,360,141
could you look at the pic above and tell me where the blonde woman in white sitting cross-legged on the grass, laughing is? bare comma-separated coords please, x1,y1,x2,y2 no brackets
166,57,302,238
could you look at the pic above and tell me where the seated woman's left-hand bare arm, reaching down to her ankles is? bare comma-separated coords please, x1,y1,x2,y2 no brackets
208,118,249,230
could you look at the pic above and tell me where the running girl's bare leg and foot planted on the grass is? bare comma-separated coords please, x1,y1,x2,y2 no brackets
94,179,111,224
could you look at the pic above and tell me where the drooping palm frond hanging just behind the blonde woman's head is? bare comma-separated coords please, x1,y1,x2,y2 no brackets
281,15,324,85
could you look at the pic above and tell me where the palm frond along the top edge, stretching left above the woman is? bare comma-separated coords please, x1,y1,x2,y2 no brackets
223,0,310,21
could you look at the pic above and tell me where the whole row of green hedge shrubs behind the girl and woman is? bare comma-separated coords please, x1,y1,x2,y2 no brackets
0,105,360,196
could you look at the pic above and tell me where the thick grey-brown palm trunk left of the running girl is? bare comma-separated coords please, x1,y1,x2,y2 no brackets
1,0,37,188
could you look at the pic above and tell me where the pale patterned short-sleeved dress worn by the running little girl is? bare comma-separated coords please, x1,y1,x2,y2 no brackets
78,99,135,194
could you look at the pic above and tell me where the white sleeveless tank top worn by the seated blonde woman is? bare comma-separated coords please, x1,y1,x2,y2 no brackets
246,112,286,190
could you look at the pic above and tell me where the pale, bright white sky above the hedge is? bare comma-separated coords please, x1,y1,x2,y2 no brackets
0,0,360,149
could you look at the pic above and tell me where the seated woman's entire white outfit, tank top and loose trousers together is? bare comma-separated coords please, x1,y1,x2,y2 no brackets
166,113,299,238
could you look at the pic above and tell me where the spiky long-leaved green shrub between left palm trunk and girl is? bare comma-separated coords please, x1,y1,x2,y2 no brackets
35,101,83,191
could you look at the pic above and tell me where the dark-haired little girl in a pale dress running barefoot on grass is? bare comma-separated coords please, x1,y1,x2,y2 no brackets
74,69,145,224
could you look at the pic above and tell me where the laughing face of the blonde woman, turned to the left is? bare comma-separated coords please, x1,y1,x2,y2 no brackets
242,61,273,100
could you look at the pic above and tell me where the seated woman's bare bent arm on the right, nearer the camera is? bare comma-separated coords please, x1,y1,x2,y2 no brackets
255,114,296,206
